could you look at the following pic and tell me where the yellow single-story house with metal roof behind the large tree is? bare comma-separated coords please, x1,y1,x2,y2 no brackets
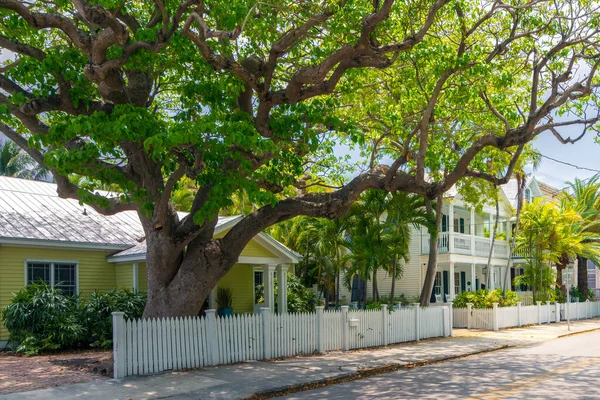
0,176,300,347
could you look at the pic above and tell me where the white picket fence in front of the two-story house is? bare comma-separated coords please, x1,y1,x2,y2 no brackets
452,301,600,330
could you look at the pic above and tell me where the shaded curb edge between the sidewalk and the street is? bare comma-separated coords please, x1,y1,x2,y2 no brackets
238,342,512,400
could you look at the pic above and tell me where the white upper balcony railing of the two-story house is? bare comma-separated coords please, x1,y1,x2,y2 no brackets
422,232,508,259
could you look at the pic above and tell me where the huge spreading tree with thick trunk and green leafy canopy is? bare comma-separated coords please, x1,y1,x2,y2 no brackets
0,0,600,317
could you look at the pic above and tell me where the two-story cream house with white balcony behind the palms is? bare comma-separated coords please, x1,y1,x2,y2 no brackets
340,178,558,302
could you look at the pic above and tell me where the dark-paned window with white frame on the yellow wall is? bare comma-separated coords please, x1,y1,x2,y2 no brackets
27,261,77,296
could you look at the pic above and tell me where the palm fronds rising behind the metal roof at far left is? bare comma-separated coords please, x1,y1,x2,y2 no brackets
0,140,49,180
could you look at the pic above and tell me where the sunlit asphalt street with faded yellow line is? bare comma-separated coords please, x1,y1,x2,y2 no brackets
285,331,600,400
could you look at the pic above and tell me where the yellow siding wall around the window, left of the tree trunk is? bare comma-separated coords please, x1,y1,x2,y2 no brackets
0,246,116,340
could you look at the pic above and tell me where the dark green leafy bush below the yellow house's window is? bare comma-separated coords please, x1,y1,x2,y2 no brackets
2,283,146,355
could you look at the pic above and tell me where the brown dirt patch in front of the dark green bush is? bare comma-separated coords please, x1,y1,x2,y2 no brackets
0,350,112,395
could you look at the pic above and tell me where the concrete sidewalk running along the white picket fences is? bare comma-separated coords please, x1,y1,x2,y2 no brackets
0,319,600,400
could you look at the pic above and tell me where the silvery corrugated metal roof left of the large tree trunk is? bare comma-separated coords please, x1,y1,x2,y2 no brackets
0,176,144,246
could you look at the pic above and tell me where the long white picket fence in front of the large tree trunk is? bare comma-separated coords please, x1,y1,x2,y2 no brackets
113,305,452,378
